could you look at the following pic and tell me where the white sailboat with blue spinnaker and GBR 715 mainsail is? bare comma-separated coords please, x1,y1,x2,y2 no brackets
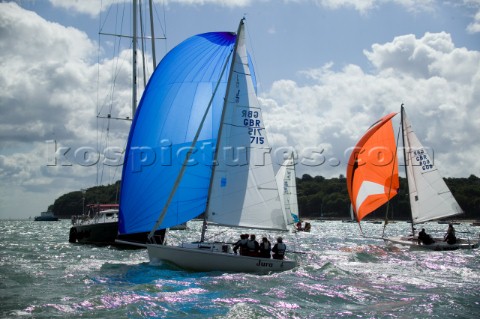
120,19,296,273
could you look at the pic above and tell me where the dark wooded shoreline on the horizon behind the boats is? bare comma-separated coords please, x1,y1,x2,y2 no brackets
49,174,480,220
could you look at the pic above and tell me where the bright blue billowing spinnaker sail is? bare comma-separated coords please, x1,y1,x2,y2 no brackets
119,32,235,234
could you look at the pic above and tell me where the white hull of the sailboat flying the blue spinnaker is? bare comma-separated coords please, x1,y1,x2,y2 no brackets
147,243,297,273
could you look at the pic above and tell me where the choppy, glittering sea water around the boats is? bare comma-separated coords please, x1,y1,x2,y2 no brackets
0,220,480,318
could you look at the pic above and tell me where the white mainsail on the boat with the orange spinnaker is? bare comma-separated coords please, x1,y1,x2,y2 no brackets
402,109,462,224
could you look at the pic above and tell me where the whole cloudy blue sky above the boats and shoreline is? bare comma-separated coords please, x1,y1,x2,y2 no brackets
0,0,480,218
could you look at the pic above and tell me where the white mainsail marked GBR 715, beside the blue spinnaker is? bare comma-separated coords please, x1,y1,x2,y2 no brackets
207,24,287,230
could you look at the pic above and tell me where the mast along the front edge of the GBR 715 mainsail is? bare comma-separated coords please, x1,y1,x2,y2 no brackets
200,18,245,242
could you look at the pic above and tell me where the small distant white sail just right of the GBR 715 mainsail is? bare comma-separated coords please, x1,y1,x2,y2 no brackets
275,153,300,224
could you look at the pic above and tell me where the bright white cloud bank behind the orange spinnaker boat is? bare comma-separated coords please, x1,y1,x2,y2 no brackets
263,32,480,177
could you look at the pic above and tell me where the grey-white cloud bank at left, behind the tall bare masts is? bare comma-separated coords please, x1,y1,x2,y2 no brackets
0,3,137,215
